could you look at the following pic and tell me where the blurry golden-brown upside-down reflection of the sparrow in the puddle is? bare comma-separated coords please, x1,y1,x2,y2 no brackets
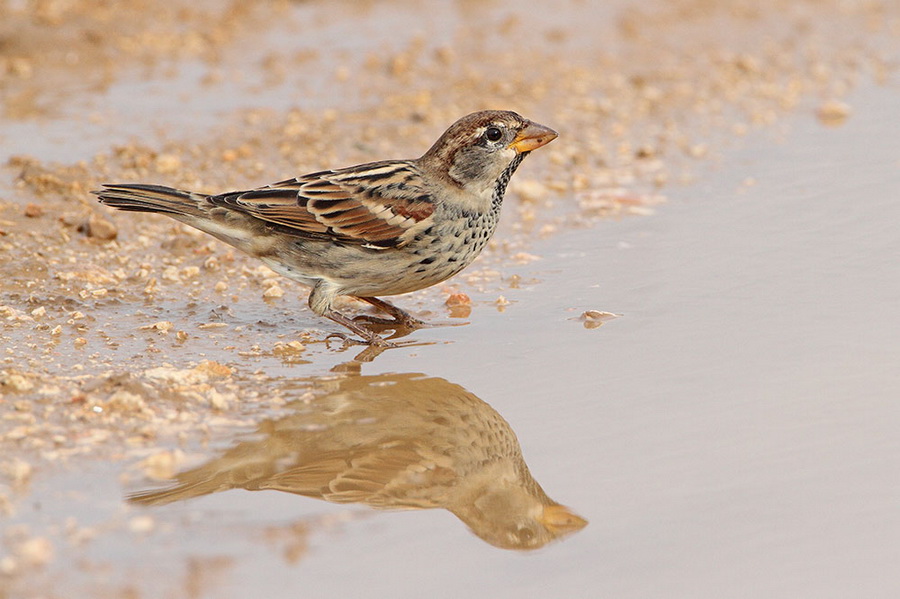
129,374,587,549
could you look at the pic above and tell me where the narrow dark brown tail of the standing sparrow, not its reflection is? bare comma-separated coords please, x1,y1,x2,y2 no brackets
91,183,208,220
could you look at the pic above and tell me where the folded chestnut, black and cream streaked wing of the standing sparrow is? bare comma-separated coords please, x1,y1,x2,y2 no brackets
209,161,435,248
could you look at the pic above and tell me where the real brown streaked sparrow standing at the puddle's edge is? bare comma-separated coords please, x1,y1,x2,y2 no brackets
92,110,558,347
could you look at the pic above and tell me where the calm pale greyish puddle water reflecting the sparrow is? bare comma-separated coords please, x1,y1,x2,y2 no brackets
0,0,900,597
